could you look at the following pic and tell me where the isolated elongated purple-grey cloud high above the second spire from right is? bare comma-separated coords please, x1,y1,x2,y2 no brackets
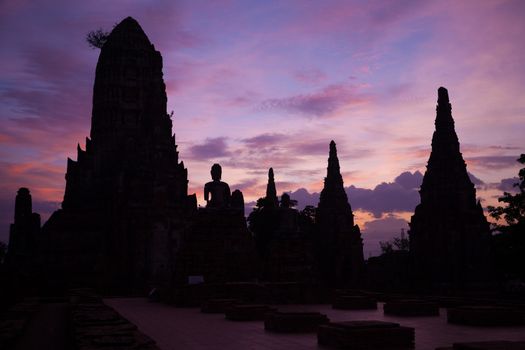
259,84,369,117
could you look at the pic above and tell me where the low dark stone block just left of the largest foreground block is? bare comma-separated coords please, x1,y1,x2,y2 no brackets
264,312,330,333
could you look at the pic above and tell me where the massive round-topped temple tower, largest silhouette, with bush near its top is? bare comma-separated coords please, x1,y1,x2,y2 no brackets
44,17,196,292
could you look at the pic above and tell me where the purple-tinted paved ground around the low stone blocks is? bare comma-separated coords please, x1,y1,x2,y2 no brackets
104,298,525,350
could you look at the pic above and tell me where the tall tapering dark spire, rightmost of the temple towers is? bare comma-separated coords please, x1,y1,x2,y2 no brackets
409,87,489,286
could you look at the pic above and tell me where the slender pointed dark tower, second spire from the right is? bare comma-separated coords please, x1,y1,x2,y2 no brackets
316,141,364,287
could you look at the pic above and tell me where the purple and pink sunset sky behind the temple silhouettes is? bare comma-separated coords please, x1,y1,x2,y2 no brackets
0,0,525,257
